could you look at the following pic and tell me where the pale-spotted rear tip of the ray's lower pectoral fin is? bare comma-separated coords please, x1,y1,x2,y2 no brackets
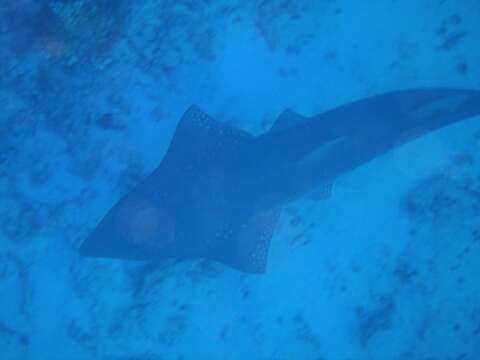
236,208,281,274
